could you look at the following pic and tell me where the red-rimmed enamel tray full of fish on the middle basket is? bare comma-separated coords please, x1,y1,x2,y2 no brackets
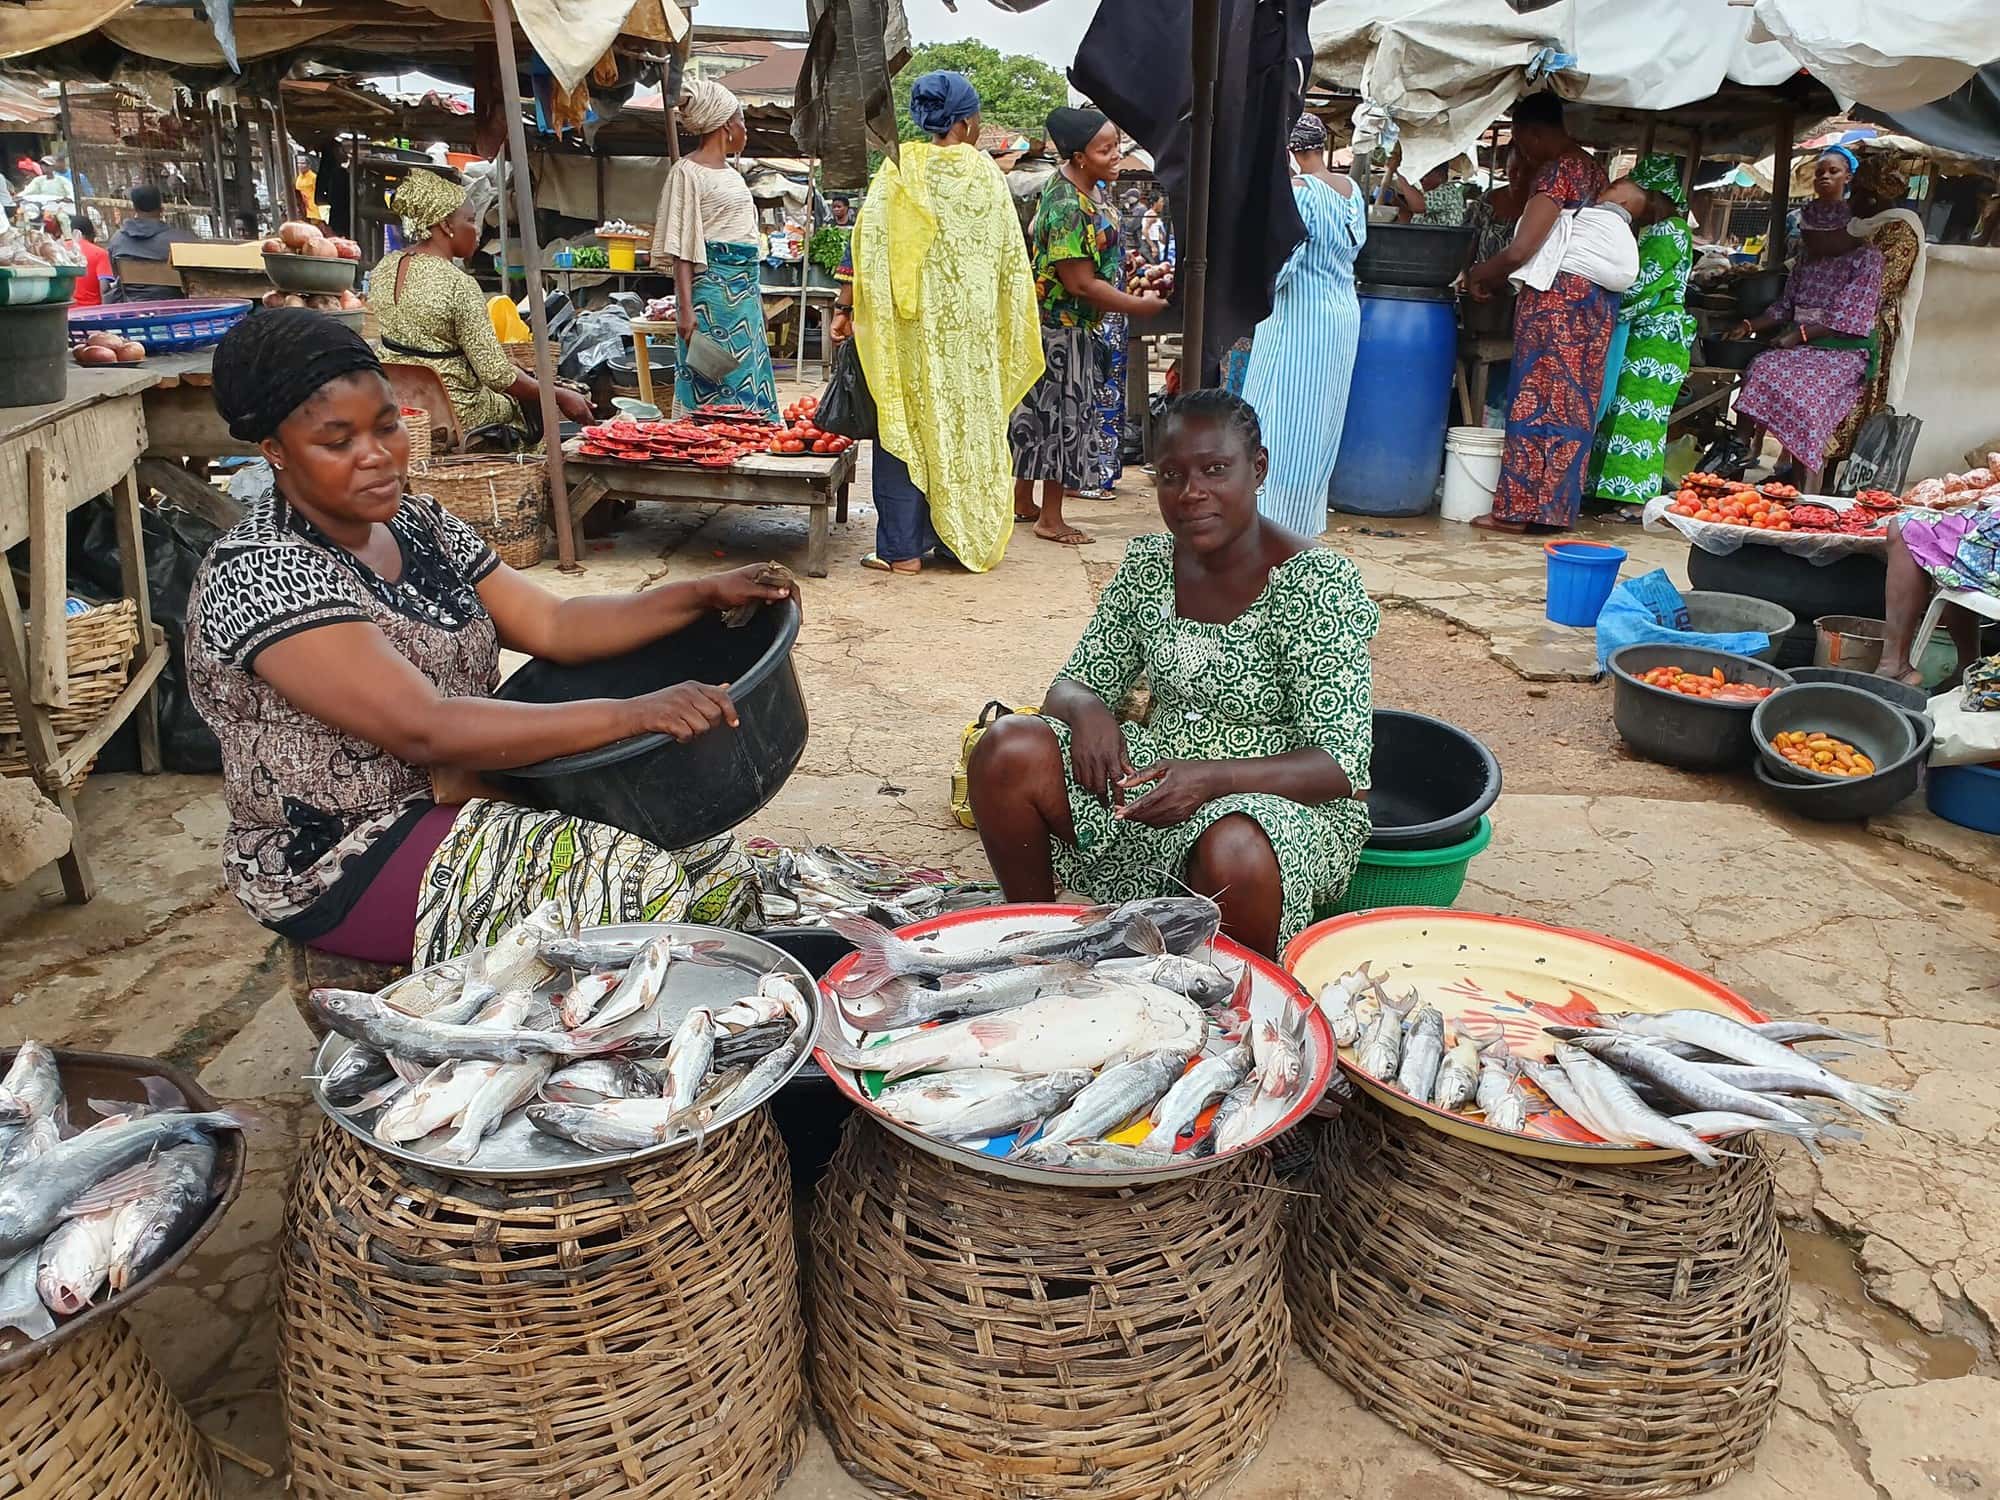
812,906,1334,1188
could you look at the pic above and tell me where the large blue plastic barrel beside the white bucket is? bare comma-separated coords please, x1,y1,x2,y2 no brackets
1334,284,1458,516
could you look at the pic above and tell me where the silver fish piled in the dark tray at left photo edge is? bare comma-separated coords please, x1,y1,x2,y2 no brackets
0,1042,238,1348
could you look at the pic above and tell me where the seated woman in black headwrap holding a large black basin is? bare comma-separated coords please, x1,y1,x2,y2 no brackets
188,308,788,964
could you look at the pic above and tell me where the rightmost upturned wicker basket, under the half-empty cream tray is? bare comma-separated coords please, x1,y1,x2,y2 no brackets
1286,1100,1790,1500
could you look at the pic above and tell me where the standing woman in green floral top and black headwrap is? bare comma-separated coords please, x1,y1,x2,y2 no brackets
1008,110,1166,546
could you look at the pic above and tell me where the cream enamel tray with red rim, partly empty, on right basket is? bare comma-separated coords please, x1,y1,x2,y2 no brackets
1284,906,1764,1162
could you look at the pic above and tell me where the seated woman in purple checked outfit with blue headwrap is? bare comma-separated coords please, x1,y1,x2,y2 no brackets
1732,148,1882,494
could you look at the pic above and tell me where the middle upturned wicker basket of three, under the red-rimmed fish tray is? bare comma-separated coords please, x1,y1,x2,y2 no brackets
808,1114,1288,1500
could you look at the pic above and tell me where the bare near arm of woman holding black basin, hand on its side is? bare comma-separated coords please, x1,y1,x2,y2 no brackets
250,622,736,770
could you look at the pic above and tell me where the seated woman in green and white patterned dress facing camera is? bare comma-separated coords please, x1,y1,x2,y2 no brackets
970,390,1380,954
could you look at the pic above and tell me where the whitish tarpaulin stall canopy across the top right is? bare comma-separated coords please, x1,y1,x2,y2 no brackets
1312,0,1996,178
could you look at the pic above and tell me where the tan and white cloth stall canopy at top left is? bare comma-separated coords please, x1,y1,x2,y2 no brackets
0,0,688,90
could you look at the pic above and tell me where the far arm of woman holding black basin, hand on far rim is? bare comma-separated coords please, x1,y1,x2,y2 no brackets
478,562,798,664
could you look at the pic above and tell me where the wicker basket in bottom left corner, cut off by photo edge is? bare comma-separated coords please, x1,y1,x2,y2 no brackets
0,1316,216,1500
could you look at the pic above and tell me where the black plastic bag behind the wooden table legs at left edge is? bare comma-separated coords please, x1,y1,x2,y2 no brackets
70,500,222,774
